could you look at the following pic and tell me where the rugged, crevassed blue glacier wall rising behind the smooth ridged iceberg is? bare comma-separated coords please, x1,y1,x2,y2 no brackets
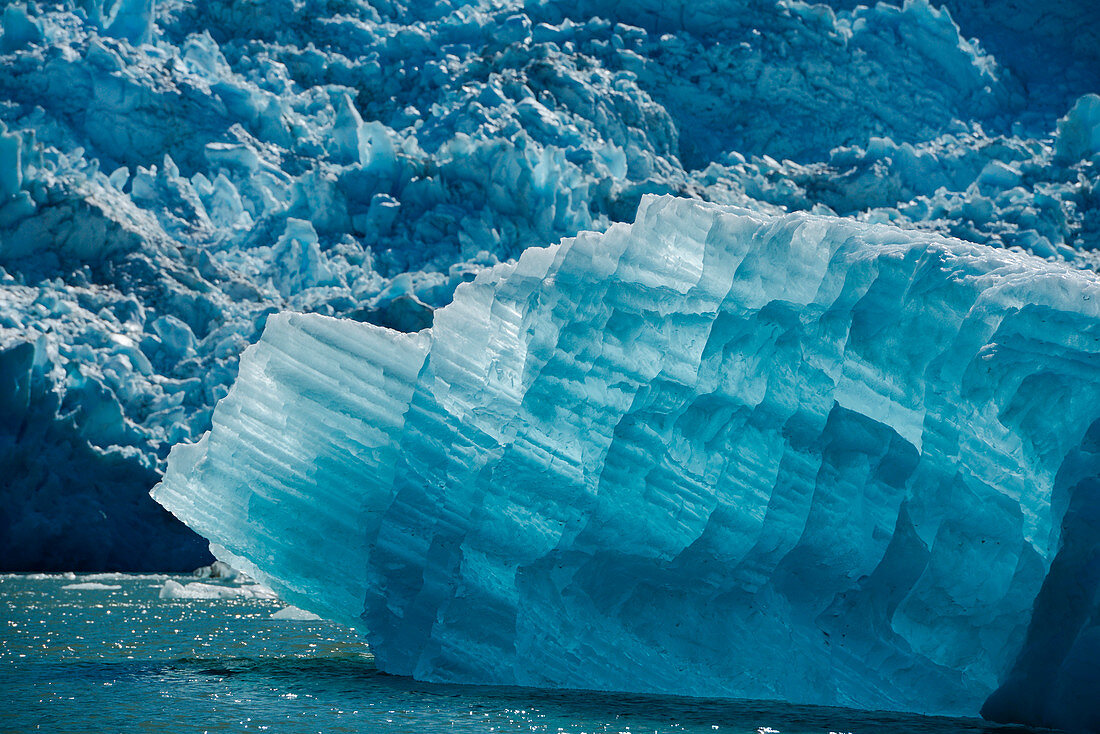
0,0,1100,570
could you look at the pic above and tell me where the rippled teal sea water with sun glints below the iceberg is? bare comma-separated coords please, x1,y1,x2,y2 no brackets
0,574,1060,734
